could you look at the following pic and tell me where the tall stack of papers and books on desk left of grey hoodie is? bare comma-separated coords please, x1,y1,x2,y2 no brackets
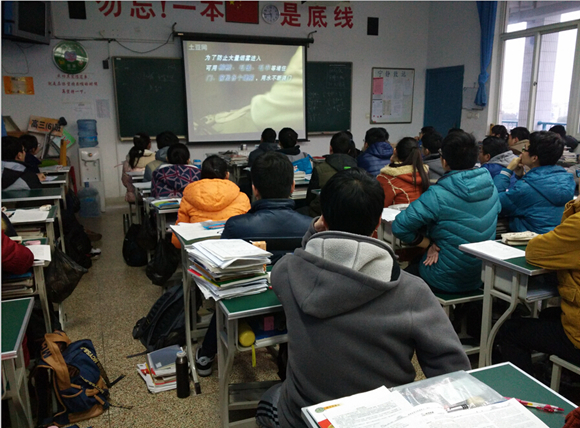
187,239,272,301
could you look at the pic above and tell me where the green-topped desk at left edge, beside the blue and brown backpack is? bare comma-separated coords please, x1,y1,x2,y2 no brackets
2,297,34,428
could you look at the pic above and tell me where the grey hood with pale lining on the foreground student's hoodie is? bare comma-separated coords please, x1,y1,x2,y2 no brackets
288,231,401,319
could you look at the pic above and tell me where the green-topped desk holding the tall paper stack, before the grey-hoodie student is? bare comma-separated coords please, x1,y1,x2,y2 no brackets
216,290,288,428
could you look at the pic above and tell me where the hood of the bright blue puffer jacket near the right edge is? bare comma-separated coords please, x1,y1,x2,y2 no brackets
523,165,576,206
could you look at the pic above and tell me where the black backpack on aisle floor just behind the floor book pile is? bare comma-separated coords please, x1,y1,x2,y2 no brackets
133,284,185,352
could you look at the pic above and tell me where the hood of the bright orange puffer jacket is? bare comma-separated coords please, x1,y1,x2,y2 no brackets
183,178,240,212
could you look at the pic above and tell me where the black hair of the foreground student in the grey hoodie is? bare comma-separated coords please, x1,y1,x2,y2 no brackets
320,168,385,236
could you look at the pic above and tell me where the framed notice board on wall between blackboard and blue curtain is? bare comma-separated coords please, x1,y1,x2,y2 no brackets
370,67,415,123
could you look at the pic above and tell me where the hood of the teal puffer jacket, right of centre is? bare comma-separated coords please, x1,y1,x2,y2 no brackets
437,168,495,202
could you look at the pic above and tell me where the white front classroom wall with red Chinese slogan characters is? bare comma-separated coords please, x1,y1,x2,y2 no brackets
2,2,483,198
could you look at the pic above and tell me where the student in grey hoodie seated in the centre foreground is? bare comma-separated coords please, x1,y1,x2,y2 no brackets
256,168,470,428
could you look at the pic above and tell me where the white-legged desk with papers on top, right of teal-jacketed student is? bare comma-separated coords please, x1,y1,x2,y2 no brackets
459,243,558,366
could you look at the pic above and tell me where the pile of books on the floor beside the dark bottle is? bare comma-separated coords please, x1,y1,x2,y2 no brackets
137,345,182,394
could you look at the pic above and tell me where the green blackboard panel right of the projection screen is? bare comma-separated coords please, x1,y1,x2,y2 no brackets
306,62,352,133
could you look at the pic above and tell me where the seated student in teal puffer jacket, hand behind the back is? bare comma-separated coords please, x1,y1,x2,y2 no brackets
393,132,500,293
